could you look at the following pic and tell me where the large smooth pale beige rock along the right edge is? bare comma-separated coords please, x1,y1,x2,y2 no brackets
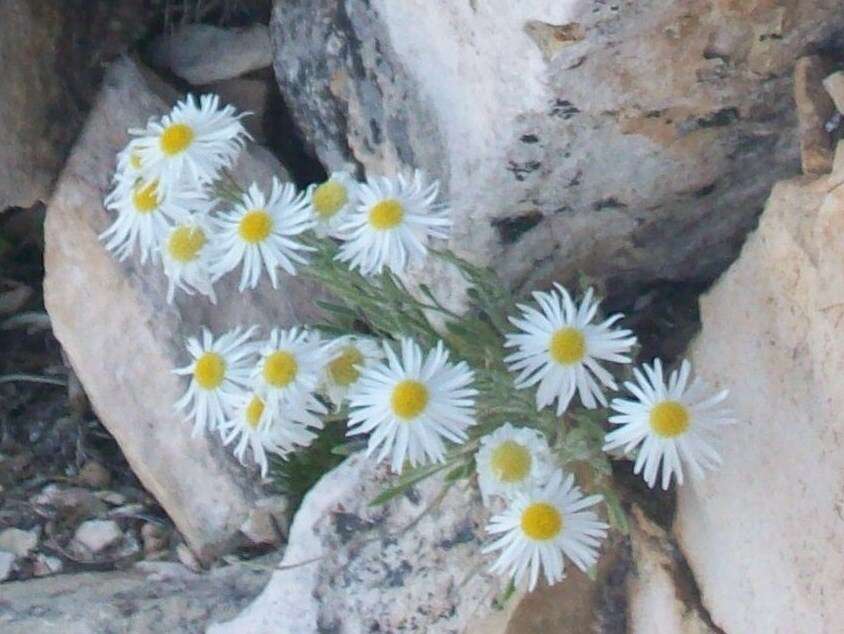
675,162,844,634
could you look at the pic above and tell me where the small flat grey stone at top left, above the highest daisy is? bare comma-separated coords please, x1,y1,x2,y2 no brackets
150,24,273,86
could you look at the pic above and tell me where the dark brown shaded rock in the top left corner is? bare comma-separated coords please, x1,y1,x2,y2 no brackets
0,0,148,211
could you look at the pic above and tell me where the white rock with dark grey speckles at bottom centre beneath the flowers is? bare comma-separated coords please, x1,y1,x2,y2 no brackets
209,454,616,634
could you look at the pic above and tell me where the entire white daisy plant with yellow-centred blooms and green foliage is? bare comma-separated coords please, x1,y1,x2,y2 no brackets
102,95,733,589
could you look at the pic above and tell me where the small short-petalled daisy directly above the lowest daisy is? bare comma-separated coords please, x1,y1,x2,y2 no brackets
475,423,552,501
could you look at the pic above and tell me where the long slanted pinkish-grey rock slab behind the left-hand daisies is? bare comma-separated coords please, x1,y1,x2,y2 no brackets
44,60,322,560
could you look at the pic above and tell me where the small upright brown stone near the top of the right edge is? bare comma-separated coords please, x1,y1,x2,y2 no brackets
794,55,835,174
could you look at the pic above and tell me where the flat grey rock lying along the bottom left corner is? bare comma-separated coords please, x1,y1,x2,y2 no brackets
0,560,272,634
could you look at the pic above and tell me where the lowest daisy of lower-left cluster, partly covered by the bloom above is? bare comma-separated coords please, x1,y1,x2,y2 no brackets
220,391,322,477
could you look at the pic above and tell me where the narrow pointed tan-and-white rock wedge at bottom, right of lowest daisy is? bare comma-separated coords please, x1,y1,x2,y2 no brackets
627,507,721,634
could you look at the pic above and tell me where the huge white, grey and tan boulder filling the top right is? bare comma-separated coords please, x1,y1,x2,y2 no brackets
270,0,844,292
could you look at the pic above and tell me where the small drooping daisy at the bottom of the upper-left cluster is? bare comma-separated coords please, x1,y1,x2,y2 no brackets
160,212,217,304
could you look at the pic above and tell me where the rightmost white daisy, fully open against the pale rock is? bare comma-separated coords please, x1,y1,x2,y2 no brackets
604,359,735,489
